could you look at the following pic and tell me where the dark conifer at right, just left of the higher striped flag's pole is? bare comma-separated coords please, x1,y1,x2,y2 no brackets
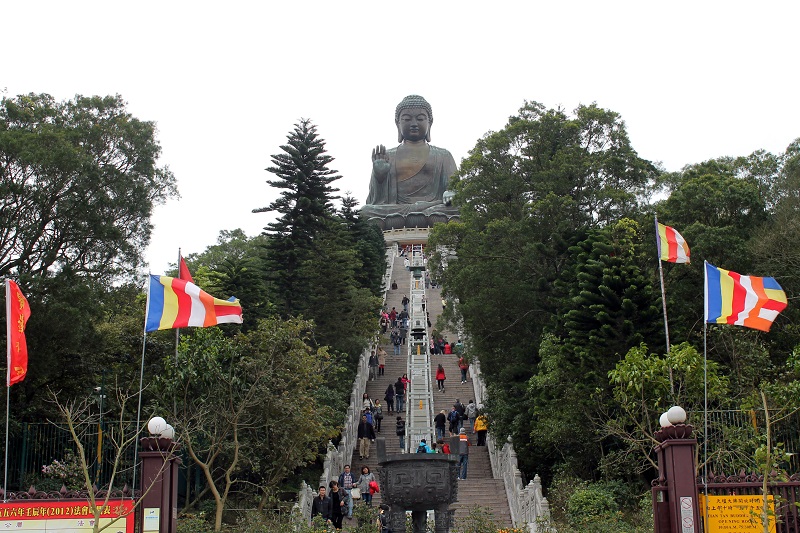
525,219,663,477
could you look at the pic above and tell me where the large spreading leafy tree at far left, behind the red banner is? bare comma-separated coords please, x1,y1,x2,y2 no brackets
0,94,176,419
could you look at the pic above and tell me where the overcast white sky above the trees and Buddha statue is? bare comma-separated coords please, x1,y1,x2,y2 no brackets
0,0,800,273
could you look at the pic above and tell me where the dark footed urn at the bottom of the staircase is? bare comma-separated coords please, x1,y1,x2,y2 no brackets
377,438,458,533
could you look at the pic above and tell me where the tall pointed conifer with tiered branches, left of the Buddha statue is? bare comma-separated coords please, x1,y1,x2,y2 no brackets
253,119,341,316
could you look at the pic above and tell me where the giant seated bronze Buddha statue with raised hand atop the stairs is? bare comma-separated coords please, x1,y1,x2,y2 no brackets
361,94,458,229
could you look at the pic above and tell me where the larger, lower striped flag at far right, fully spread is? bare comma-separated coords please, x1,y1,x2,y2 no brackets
705,261,787,331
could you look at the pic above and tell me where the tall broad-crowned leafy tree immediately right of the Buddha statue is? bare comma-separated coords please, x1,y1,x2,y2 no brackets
430,102,656,471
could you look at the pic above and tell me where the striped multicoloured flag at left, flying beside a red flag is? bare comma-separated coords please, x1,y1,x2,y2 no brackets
145,275,242,331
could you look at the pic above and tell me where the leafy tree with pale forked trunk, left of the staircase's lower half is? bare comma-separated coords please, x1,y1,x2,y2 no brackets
155,319,333,531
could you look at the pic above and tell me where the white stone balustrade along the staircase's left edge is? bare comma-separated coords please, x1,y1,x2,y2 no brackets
297,246,397,520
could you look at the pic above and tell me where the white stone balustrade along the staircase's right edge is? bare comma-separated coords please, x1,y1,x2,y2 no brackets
469,360,552,533
